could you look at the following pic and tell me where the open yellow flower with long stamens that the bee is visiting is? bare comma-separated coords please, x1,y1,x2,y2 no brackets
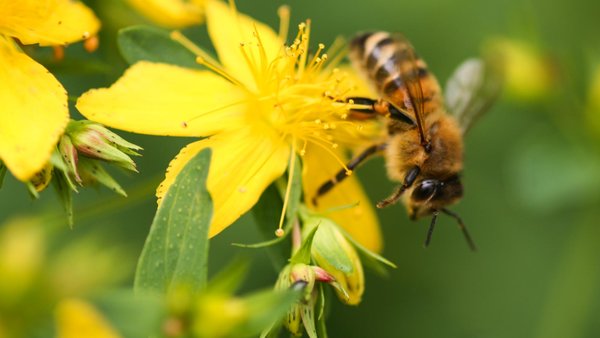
77,1,381,250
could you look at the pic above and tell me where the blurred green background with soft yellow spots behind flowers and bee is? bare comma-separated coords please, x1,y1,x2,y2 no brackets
0,0,600,338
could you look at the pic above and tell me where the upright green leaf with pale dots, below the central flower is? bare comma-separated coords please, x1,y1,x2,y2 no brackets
135,149,212,293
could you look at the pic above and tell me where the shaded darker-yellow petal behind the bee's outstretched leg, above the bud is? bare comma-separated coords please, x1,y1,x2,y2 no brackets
302,146,383,252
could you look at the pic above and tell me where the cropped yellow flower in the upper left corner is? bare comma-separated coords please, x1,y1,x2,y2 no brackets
0,0,100,181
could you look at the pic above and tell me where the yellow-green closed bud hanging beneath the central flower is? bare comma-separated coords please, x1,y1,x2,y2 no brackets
304,217,365,305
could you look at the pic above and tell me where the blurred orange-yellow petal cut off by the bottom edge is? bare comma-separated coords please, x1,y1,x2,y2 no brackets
56,298,121,338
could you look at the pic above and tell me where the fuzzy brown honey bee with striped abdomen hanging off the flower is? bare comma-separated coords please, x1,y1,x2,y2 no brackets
313,32,501,250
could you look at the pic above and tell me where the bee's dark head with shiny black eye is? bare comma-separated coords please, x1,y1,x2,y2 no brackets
405,174,463,219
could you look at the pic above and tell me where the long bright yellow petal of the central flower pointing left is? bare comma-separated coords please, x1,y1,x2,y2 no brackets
76,62,245,136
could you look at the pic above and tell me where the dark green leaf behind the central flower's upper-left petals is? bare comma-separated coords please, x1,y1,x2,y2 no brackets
117,26,204,69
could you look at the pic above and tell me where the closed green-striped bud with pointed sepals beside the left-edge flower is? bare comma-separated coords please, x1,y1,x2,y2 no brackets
66,120,142,172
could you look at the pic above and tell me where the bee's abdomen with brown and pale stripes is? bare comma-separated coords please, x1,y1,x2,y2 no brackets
350,32,442,115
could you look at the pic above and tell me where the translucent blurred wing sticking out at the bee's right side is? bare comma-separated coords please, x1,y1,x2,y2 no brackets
445,58,503,134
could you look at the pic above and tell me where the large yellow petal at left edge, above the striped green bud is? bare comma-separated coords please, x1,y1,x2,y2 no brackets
0,36,69,181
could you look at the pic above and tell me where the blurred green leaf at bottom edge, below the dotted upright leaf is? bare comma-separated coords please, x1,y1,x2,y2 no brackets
93,290,167,338
